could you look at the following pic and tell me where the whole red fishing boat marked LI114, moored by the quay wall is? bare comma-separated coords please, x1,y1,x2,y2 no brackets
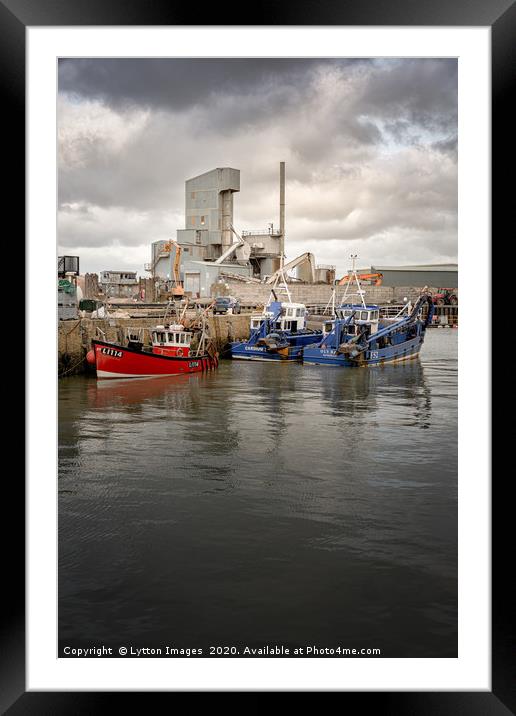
86,324,218,378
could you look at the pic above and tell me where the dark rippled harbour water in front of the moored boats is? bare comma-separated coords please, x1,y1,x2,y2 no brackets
58,329,457,657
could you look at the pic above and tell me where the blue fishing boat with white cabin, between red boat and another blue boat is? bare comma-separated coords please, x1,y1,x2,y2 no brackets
231,273,322,361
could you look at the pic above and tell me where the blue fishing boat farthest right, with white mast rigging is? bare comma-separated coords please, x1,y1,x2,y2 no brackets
303,257,434,368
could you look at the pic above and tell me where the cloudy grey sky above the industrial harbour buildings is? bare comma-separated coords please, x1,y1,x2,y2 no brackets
58,59,457,275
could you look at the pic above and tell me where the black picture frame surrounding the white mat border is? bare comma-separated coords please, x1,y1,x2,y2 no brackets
6,0,510,716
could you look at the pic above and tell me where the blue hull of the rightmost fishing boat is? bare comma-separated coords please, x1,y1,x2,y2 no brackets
303,335,424,368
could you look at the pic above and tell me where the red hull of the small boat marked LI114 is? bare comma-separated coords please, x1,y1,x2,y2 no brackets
92,340,218,378
